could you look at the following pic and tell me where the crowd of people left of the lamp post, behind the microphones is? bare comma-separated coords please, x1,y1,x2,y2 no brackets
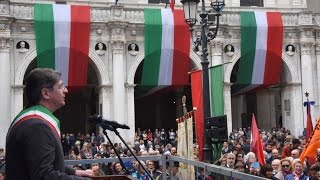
57,128,179,179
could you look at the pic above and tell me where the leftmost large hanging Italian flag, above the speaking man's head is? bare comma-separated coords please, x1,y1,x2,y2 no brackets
34,4,90,87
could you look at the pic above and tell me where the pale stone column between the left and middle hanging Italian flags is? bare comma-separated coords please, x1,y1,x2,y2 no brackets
111,27,127,142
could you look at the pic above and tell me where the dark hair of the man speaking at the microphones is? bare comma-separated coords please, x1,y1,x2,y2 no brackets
26,68,61,107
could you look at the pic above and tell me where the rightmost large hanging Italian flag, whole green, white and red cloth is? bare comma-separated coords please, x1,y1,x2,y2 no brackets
234,11,283,94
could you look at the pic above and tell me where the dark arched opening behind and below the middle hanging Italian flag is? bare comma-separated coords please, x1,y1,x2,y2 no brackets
134,60,197,130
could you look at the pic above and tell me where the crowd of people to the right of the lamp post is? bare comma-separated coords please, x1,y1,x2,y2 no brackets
215,128,320,180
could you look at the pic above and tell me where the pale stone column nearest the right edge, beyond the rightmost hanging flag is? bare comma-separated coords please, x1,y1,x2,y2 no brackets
300,29,316,127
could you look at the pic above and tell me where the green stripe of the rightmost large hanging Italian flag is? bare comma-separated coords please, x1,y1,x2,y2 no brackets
236,12,257,85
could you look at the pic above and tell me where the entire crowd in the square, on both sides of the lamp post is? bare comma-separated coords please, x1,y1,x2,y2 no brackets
0,128,320,180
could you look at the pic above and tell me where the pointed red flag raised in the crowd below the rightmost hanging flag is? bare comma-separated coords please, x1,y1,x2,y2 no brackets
250,113,266,165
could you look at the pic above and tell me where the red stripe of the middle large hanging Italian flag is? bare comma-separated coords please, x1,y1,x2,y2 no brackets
172,10,191,85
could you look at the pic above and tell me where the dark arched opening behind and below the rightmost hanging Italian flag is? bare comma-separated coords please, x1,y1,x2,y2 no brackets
230,58,293,130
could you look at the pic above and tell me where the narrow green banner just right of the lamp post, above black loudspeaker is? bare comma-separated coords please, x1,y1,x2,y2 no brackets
209,65,224,117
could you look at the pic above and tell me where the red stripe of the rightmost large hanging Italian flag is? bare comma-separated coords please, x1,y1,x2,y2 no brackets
263,12,283,85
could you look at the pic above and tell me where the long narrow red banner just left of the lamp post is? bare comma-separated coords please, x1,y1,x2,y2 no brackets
191,71,204,161
